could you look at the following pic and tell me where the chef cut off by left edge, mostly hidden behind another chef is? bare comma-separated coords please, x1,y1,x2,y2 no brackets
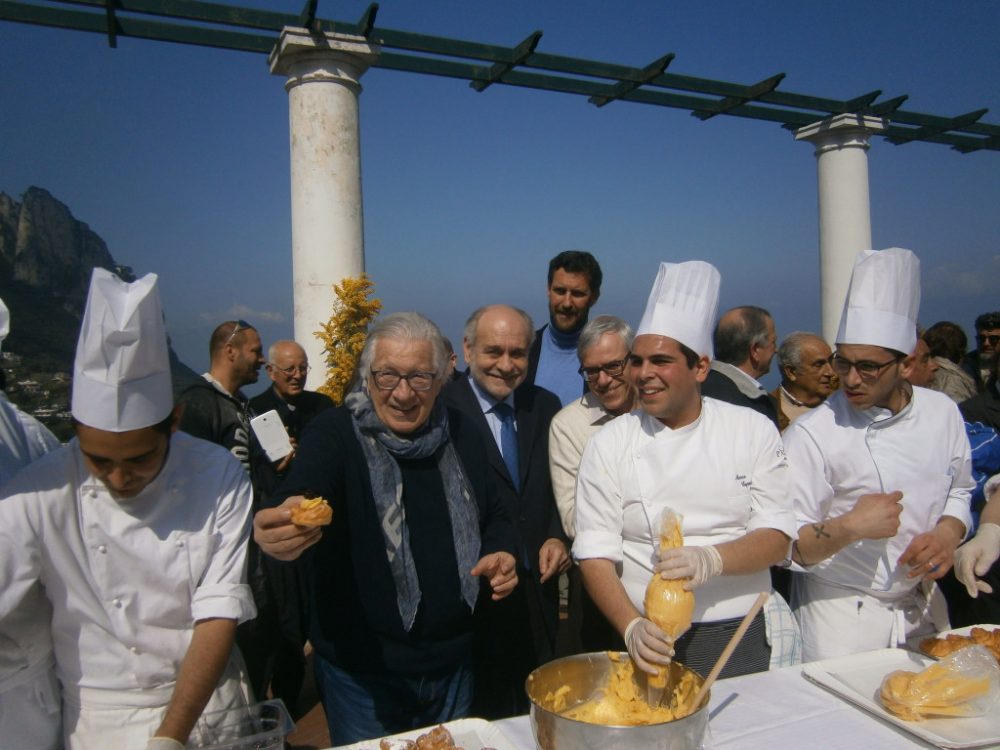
0,300,62,750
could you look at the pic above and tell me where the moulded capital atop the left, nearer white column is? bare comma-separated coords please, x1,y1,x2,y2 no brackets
267,26,380,90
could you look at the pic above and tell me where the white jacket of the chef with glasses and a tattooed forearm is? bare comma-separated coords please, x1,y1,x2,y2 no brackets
784,388,974,601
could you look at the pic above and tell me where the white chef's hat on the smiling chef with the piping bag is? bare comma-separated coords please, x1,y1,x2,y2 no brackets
635,260,722,359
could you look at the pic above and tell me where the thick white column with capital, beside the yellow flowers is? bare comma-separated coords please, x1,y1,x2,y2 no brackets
268,27,379,388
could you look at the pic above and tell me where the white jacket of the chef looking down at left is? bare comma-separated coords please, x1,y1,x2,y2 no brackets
0,432,255,706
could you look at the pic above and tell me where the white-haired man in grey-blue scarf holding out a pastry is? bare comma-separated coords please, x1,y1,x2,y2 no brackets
254,313,517,745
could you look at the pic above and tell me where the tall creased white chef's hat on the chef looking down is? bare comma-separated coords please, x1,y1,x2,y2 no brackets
73,268,174,432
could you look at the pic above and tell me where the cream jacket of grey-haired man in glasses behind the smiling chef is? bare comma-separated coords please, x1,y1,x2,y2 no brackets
549,391,614,539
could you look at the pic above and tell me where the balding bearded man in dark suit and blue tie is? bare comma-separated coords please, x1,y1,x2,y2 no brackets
443,305,570,719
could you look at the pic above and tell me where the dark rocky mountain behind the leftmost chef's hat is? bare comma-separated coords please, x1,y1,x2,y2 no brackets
0,187,198,438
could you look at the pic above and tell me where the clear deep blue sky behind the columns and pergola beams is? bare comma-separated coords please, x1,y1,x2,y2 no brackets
0,0,1000,396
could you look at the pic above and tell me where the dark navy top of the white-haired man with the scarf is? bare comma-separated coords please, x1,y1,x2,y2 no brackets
268,407,514,676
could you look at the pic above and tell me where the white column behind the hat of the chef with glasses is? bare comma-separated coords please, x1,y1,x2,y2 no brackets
795,114,886,346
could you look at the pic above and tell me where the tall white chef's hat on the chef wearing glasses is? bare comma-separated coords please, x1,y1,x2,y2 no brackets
836,247,920,354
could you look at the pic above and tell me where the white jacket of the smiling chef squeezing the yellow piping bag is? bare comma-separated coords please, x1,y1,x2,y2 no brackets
573,398,796,622
